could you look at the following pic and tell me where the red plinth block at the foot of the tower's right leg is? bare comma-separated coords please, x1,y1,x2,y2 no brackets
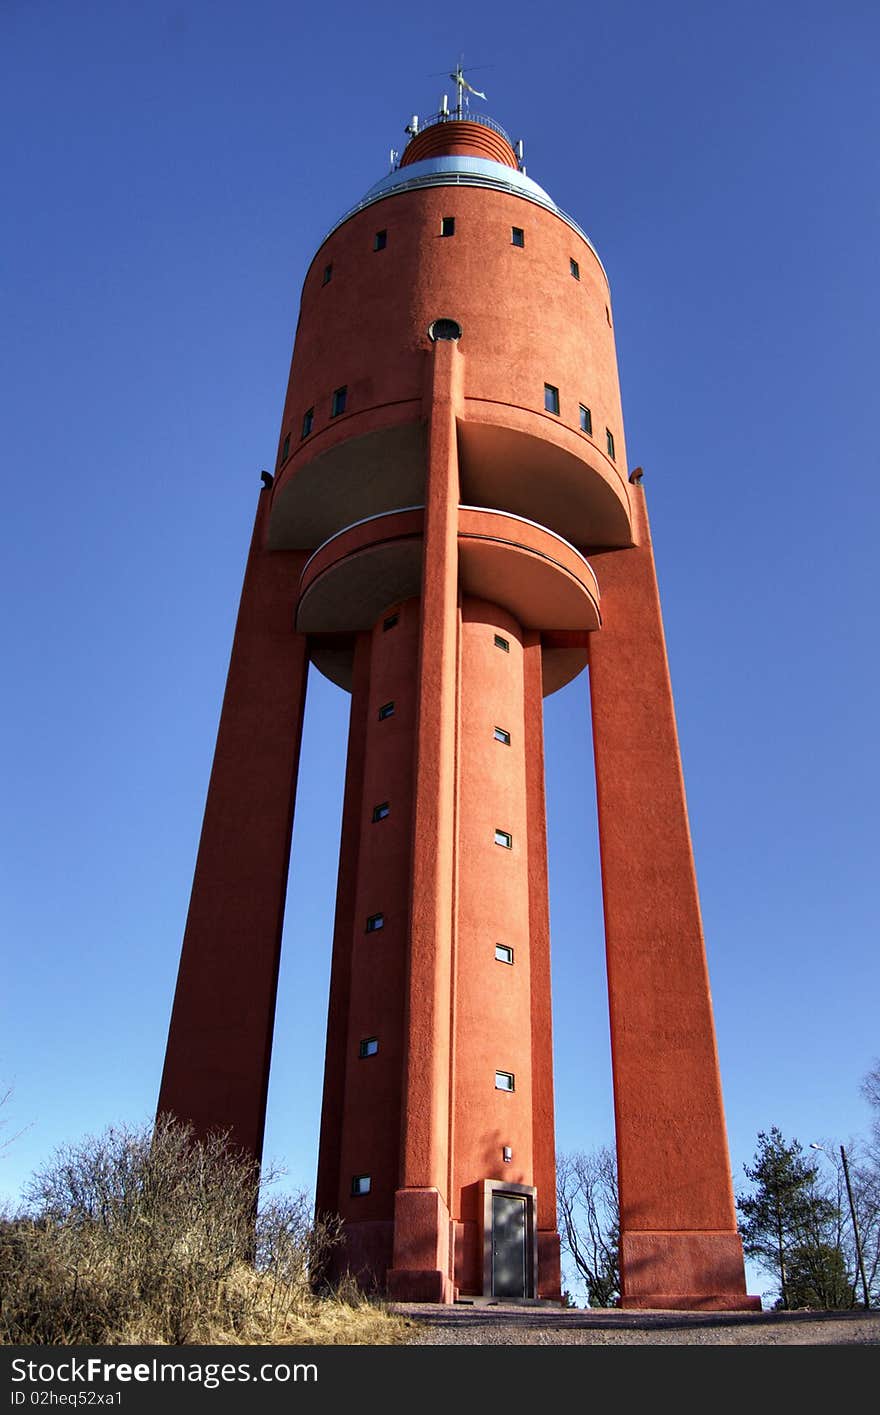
620,1232,761,1312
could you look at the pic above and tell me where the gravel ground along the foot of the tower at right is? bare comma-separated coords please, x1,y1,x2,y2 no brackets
393,1302,880,1346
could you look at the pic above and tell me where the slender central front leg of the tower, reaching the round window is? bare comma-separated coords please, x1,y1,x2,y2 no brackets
388,333,463,1302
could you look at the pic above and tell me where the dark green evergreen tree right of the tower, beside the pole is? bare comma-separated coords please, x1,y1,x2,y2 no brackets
737,1125,852,1307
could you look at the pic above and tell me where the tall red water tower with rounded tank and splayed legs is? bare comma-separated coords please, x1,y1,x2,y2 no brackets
160,85,757,1309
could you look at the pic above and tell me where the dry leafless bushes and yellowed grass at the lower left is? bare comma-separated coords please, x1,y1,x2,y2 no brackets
0,1122,409,1346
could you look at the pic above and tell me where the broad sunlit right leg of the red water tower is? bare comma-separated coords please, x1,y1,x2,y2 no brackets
590,487,760,1309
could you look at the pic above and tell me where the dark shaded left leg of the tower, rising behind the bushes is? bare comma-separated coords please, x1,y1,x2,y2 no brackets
158,490,308,1160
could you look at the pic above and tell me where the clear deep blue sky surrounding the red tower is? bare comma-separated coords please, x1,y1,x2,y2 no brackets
0,0,880,1301
